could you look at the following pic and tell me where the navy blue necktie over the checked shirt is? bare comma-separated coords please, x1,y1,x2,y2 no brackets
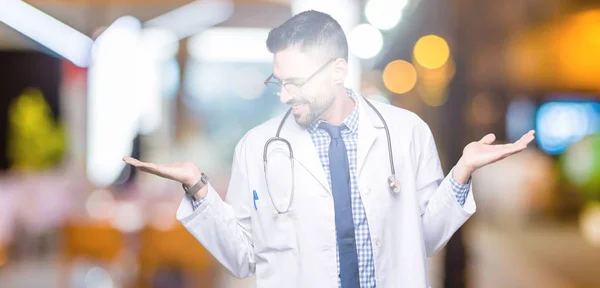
319,122,360,288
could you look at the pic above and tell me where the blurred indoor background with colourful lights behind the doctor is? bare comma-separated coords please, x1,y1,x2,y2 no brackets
0,0,600,288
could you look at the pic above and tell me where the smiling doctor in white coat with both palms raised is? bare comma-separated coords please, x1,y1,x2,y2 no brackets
124,11,534,288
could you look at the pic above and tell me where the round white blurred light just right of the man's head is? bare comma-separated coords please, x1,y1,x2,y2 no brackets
348,24,383,59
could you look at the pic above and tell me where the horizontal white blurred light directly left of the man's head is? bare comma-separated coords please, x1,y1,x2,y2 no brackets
187,27,273,62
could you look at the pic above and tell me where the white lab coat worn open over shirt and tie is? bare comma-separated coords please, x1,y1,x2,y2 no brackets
177,97,475,288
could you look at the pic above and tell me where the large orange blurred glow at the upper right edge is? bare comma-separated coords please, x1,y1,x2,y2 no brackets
504,9,600,91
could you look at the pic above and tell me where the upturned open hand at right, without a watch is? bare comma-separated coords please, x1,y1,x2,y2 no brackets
452,130,535,184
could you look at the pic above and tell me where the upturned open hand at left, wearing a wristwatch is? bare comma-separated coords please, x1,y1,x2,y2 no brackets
123,157,208,197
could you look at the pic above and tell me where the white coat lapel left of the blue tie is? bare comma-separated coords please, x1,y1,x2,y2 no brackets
281,115,331,193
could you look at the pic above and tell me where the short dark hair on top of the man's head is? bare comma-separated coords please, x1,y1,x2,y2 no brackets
267,10,348,61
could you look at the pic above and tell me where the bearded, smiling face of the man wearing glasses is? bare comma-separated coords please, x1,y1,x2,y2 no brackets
273,48,335,128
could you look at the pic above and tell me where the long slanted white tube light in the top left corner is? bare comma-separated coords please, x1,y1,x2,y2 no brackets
0,0,93,68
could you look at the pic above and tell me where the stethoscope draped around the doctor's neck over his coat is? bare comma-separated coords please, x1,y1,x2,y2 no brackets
263,96,400,214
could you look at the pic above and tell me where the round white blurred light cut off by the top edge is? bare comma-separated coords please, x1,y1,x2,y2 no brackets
365,0,408,30
